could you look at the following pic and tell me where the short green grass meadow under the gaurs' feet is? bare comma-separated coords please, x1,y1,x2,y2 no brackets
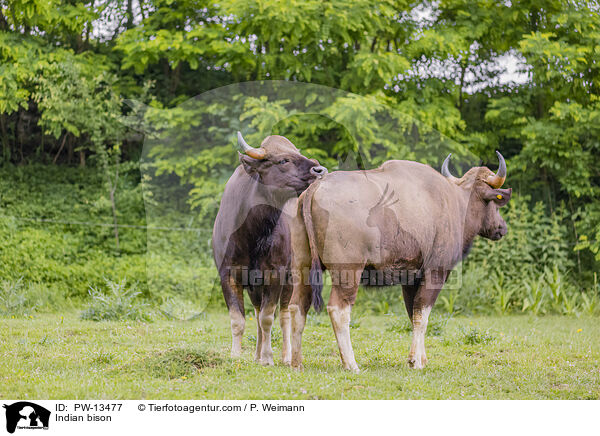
0,313,600,399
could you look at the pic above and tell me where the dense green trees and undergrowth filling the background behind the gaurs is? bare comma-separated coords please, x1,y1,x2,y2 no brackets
0,0,600,313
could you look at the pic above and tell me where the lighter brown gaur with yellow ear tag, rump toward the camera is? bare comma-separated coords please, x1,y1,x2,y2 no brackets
289,152,512,371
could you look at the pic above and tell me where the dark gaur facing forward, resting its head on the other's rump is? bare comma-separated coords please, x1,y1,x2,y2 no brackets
212,132,327,365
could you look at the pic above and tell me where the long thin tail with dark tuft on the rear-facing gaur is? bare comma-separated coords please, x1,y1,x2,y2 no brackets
302,181,323,312
